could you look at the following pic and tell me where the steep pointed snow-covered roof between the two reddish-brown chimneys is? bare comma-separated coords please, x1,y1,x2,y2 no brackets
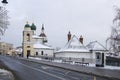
57,35,89,52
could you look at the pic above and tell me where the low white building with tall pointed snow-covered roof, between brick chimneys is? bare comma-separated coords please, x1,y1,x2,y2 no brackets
55,35,92,59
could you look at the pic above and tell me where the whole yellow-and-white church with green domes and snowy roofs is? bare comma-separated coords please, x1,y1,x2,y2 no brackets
22,23,54,57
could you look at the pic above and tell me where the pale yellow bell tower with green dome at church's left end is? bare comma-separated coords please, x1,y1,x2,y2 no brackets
22,22,34,57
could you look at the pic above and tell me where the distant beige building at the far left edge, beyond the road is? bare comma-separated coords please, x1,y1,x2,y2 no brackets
0,42,13,55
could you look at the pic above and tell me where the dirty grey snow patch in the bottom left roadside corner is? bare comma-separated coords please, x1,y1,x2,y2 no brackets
0,69,14,80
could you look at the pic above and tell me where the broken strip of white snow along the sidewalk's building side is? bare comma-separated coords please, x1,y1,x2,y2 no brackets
29,57,120,70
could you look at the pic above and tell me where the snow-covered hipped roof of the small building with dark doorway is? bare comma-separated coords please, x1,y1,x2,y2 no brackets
86,41,107,50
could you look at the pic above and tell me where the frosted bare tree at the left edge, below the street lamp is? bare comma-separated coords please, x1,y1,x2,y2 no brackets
0,6,9,35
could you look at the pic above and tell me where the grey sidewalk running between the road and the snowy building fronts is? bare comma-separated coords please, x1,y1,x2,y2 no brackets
20,58,120,80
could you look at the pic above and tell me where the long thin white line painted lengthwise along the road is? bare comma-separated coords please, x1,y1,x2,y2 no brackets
19,63,66,80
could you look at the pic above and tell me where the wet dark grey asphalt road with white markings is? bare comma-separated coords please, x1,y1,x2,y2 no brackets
0,56,110,80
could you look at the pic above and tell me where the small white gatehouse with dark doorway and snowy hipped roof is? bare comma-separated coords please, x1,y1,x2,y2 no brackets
86,41,108,66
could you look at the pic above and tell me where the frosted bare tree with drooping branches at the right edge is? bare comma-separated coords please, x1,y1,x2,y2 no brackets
107,8,120,55
